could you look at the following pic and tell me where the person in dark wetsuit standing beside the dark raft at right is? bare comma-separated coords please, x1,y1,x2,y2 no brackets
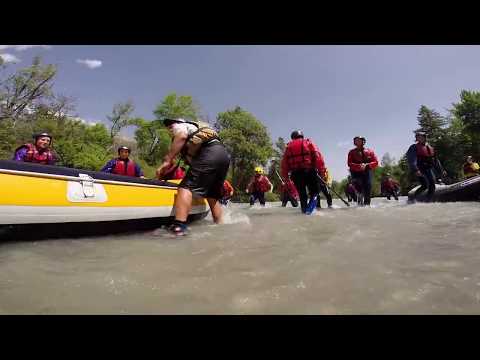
407,131,447,202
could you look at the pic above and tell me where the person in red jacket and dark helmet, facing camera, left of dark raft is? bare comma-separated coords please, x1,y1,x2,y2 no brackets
347,136,378,205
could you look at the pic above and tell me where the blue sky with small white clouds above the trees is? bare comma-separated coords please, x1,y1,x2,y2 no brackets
0,45,480,179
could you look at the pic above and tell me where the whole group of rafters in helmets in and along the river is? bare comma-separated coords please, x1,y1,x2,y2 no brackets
13,123,480,235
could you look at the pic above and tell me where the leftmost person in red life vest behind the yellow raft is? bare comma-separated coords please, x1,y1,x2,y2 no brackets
13,132,55,165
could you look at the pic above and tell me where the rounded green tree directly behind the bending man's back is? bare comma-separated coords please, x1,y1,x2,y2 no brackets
215,106,273,197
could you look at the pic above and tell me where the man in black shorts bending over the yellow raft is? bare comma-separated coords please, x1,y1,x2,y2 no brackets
157,118,230,235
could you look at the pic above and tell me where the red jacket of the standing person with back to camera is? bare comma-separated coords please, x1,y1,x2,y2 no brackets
281,138,325,179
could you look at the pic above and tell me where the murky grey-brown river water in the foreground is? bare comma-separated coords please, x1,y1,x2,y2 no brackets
0,198,480,314
